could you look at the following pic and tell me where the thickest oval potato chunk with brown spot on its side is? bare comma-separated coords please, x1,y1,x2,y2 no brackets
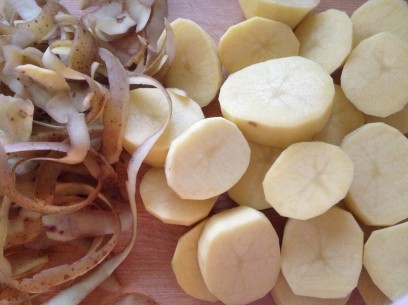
219,56,334,147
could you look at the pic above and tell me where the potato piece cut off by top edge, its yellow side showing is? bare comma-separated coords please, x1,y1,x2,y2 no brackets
239,0,320,29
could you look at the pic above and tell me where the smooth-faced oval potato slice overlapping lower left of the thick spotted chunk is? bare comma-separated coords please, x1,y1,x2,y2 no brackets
165,117,251,199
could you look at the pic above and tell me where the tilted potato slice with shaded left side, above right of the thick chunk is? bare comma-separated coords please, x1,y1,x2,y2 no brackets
295,9,353,74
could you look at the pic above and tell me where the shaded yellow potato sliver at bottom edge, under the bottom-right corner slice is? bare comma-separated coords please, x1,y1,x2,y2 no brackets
357,268,392,305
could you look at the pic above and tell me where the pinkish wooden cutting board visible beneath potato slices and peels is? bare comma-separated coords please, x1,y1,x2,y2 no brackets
61,0,370,305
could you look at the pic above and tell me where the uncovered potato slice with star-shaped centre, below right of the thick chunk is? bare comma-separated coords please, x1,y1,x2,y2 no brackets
262,142,353,219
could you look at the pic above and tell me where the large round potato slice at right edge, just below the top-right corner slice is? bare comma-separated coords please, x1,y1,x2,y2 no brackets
341,32,408,117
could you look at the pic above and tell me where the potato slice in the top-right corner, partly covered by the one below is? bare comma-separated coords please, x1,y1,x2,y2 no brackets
351,0,408,44
